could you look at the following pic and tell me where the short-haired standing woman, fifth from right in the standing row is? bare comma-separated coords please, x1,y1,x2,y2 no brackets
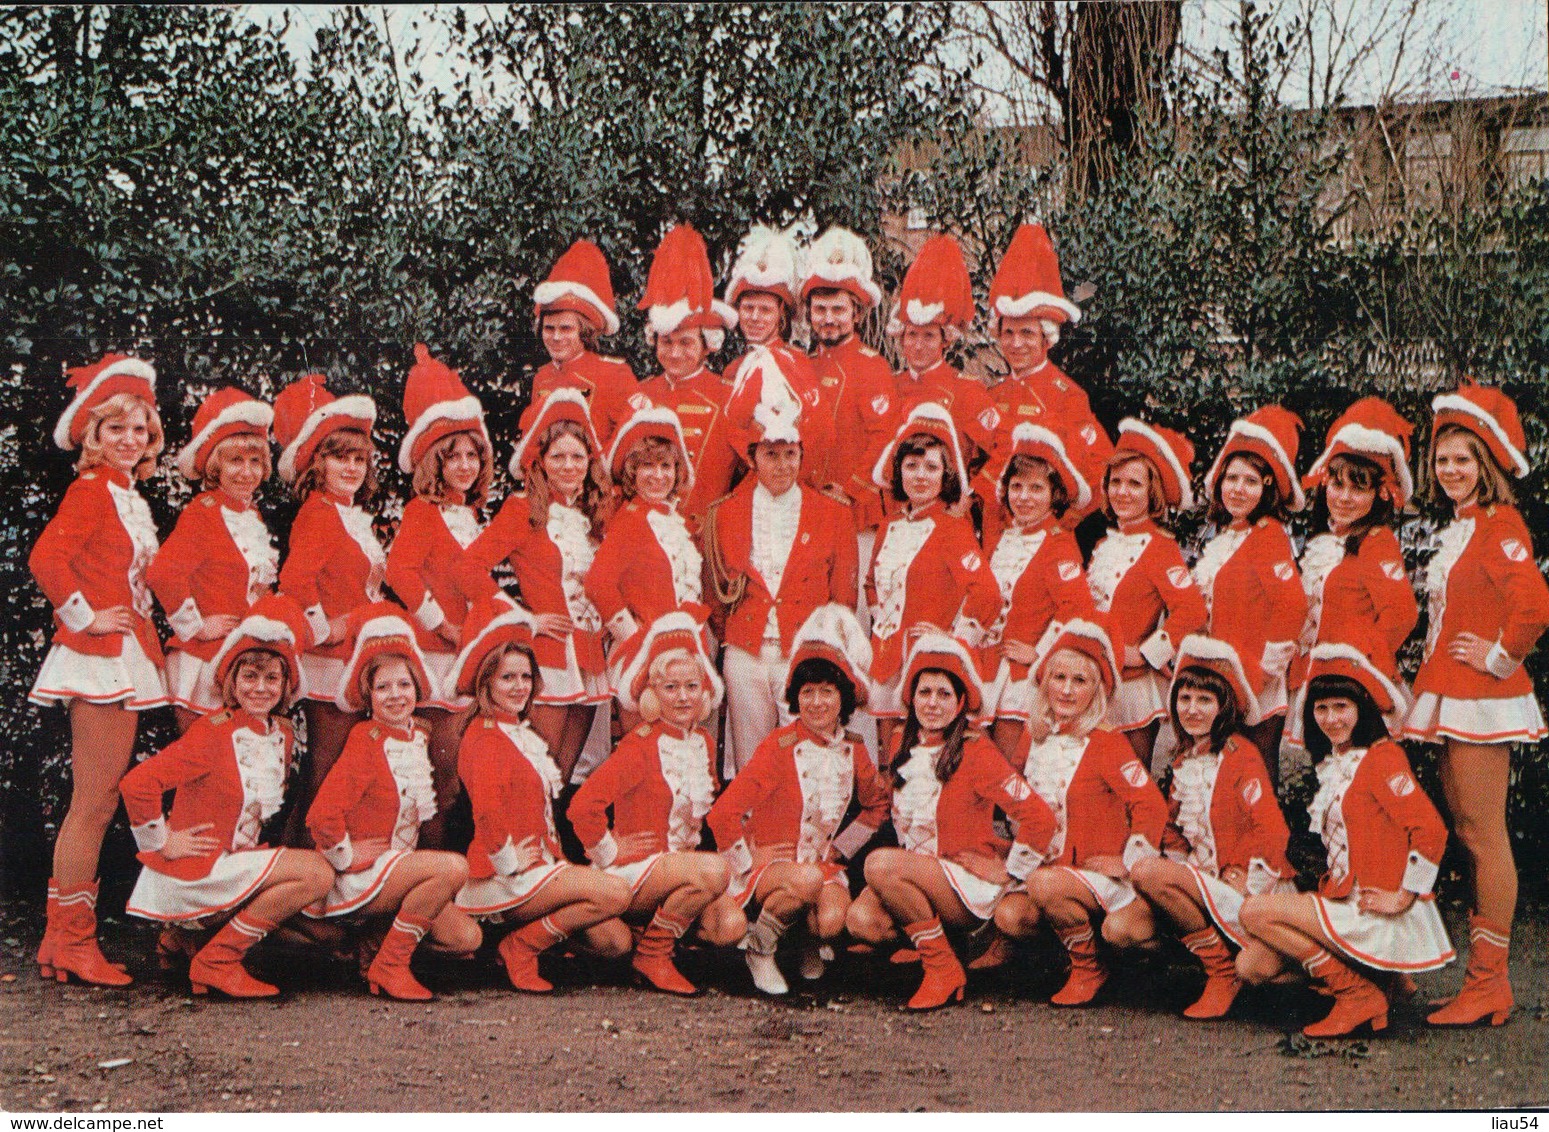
981,424,1092,759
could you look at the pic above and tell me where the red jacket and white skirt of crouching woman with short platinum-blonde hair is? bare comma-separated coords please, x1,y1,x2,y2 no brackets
570,722,716,892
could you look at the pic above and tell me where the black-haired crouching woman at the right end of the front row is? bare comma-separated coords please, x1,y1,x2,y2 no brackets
1238,644,1449,1038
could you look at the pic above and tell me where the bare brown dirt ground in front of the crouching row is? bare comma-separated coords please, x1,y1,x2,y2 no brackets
0,906,1549,1112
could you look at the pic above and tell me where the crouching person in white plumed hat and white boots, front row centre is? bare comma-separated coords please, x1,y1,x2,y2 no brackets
706,604,889,994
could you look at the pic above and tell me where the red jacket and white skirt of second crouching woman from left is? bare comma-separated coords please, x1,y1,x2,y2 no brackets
307,720,435,918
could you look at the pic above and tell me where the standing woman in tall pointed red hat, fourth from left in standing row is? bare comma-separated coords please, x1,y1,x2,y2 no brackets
386,342,494,849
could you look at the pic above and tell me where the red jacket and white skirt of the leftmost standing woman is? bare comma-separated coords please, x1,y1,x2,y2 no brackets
26,466,169,711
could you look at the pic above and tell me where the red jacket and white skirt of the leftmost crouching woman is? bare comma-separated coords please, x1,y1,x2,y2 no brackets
118,711,296,928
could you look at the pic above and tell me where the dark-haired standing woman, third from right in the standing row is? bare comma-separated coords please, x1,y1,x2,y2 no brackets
1194,404,1307,785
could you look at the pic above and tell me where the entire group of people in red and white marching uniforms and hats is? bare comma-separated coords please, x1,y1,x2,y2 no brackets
29,216,1549,1034
